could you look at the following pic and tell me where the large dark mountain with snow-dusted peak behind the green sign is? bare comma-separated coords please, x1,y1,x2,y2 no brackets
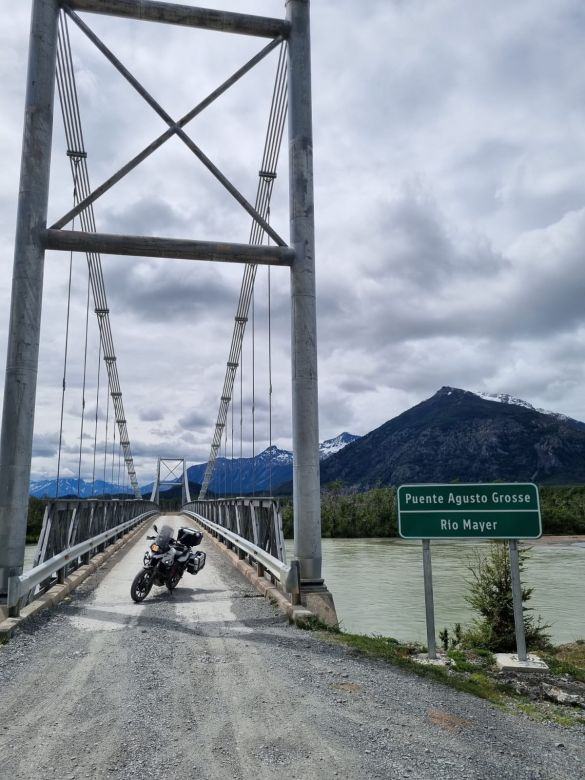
321,387,585,489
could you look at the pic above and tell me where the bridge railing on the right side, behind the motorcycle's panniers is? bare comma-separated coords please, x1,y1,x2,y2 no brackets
181,498,300,603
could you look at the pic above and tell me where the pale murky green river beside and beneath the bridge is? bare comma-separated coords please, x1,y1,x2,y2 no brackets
25,539,585,644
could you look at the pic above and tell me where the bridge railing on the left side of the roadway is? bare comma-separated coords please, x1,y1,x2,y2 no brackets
7,499,159,611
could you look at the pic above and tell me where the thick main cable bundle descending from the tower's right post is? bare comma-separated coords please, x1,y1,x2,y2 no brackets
199,42,288,498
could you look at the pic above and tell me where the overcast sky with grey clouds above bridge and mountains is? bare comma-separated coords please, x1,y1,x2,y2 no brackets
0,0,585,484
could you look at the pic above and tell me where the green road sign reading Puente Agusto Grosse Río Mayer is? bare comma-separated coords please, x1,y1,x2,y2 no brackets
397,482,542,539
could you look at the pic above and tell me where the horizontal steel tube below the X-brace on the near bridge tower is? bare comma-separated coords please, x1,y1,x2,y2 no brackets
45,230,295,266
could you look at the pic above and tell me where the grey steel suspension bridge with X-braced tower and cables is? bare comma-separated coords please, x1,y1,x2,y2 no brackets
0,0,335,621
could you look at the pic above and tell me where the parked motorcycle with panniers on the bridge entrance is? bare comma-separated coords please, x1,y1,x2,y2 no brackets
130,525,206,603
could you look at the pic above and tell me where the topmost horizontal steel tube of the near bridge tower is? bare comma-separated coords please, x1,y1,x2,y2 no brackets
66,0,290,38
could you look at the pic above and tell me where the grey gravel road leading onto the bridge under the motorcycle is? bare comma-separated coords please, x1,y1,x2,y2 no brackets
0,516,585,780
